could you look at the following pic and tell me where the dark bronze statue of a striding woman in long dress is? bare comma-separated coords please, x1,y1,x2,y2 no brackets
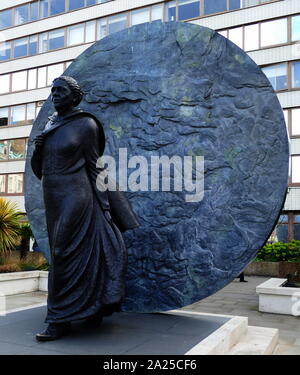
31,76,138,341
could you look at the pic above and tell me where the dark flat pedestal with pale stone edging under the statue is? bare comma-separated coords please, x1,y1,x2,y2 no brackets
0,306,278,356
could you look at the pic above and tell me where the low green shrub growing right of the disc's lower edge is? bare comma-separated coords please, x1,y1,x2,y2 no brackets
256,240,300,262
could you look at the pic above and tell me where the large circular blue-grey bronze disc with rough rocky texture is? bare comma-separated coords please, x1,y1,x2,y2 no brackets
26,22,289,312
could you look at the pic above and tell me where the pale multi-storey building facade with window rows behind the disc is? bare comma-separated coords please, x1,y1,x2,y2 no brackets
0,0,300,239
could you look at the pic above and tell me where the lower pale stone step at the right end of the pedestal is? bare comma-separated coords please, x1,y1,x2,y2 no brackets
226,326,278,355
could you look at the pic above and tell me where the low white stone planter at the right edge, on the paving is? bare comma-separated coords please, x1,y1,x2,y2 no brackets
256,278,300,316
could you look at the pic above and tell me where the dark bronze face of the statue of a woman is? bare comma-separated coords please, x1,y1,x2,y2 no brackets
51,79,75,112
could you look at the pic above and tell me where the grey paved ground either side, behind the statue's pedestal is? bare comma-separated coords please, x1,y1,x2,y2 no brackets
1,276,300,355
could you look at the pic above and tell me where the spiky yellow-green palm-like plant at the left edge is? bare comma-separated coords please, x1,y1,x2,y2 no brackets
0,198,23,254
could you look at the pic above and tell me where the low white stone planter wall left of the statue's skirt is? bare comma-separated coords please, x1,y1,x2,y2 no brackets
0,271,48,296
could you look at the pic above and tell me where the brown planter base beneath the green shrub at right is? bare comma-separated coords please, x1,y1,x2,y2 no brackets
244,261,300,281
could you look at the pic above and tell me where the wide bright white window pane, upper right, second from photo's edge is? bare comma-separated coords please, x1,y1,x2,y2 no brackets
261,18,287,47
